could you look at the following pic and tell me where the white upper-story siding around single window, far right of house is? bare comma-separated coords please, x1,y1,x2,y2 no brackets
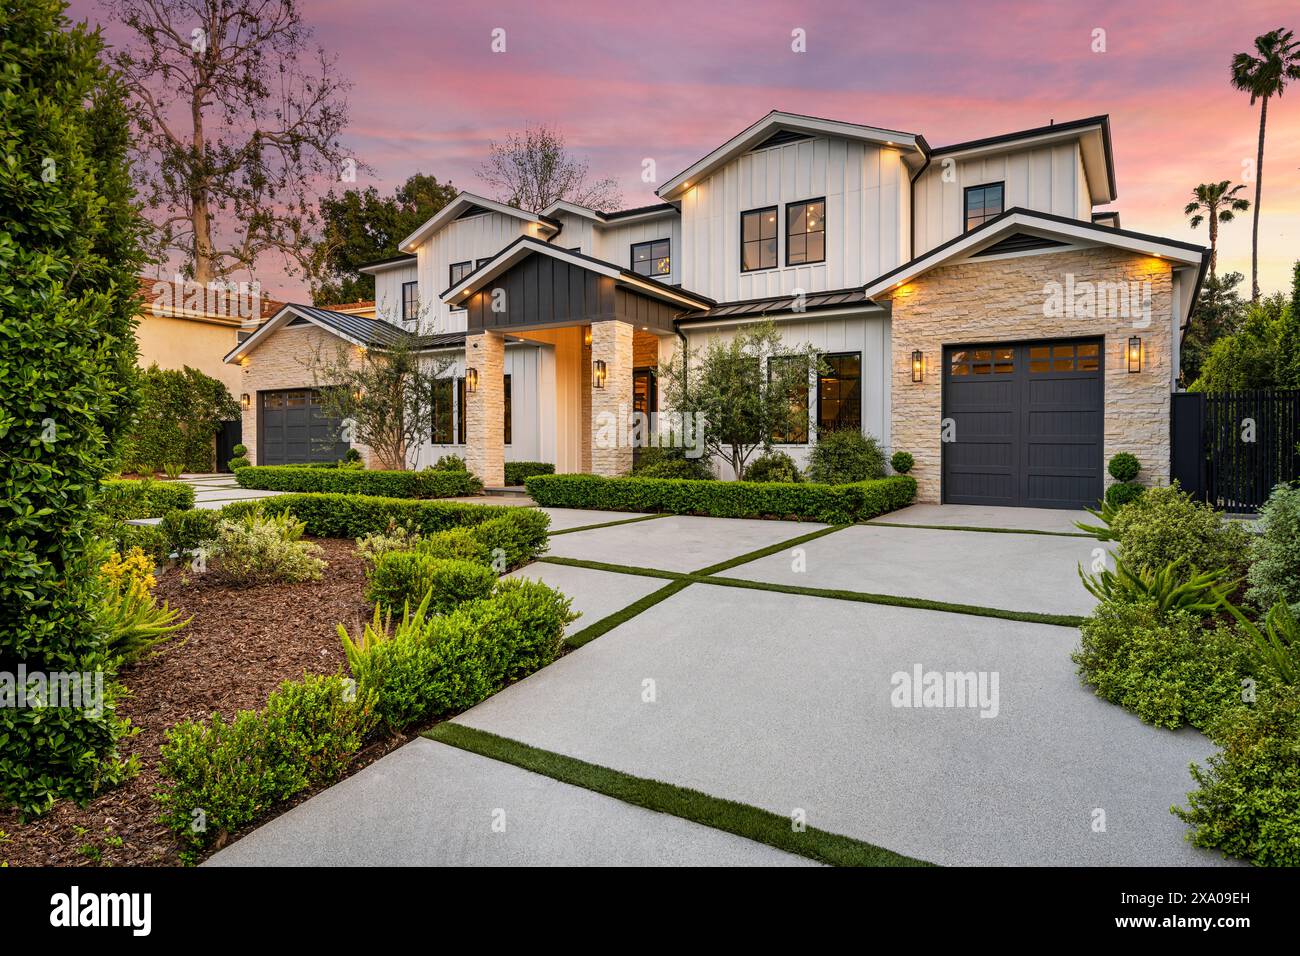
913,142,1092,256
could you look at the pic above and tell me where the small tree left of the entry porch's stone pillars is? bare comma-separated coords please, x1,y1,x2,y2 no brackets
307,339,455,468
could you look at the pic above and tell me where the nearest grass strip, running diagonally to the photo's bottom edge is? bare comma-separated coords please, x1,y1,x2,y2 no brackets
424,723,932,866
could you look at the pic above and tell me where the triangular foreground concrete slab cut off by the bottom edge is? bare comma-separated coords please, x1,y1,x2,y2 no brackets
205,737,815,866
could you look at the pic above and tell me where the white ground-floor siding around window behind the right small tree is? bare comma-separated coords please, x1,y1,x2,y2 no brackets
686,312,891,479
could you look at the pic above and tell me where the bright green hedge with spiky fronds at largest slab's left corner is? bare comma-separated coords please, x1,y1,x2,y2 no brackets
338,579,576,731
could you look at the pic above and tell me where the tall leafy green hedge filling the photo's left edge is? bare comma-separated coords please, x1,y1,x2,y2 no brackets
0,0,147,813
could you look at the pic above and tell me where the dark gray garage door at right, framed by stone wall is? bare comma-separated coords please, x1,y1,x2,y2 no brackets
944,338,1102,507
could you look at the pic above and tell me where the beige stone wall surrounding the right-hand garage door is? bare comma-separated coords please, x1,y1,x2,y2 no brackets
879,247,1173,502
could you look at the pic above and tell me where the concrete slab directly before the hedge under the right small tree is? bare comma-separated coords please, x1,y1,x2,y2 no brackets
547,512,833,571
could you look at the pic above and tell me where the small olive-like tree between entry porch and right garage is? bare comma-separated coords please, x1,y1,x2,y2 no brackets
659,320,823,475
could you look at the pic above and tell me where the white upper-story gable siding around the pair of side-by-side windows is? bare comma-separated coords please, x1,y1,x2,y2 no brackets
673,137,910,302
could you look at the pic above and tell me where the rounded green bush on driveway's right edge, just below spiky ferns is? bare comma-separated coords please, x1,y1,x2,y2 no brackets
1073,601,1251,730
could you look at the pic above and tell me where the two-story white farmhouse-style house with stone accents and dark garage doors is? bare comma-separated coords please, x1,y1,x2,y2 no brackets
228,112,1208,507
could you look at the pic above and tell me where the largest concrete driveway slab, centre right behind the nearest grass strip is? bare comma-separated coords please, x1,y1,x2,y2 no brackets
456,587,1222,866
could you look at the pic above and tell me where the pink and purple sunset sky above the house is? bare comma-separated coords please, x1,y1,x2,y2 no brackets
70,0,1300,298
